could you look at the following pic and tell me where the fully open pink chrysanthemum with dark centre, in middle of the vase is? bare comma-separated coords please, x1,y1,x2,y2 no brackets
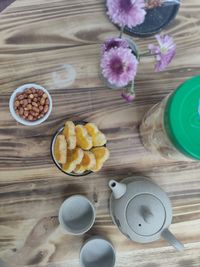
101,47,138,87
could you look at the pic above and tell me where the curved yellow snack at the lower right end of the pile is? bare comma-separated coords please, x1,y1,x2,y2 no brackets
91,147,110,172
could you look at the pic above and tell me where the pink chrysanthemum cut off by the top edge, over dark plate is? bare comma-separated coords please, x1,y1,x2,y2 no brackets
107,0,146,28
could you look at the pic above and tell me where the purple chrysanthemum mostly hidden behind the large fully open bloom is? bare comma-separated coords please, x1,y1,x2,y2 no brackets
101,38,129,54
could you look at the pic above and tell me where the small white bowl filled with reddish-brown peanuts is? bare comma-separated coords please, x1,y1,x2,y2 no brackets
9,83,52,126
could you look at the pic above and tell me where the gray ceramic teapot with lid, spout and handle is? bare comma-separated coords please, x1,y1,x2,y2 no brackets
109,177,184,251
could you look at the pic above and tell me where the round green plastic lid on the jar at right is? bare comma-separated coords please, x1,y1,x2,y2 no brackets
164,76,200,160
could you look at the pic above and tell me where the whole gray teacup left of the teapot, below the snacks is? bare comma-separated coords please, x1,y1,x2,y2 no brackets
58,195,95,235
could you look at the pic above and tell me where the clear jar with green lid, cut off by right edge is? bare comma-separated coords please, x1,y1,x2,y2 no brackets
140,76,200,161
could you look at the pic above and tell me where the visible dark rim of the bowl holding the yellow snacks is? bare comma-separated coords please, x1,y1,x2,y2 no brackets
50,121,92,177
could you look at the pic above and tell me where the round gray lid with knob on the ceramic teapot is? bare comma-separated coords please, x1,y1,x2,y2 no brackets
126,193,166,236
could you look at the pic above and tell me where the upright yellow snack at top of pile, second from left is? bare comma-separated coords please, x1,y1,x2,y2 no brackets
63,121,76,149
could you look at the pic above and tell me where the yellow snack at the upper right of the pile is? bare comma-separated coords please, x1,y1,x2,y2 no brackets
85,123,107,147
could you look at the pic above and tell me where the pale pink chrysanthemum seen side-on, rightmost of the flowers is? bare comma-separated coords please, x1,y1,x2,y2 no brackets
148,35,176,72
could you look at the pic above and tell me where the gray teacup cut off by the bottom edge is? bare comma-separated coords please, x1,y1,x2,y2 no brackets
80,236,116,267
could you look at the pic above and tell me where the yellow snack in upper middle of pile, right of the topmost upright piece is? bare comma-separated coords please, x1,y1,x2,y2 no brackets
76,125,92,150
